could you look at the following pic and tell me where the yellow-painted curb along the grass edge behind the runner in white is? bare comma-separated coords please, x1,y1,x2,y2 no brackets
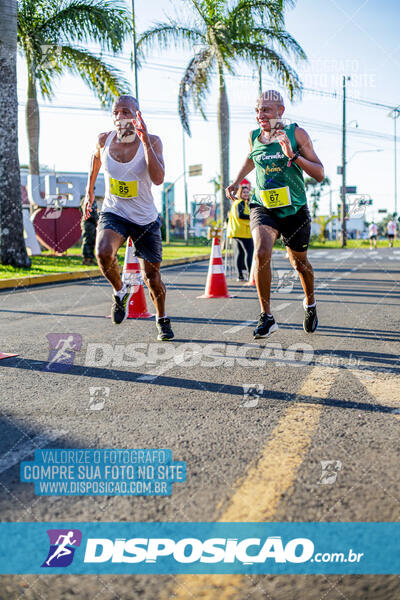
0,254,210,290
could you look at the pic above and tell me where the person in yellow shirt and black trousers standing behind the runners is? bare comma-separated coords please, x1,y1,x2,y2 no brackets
228,179,254,281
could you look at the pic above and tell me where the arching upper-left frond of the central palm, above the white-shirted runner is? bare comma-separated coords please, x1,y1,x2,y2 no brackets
137,19,207,49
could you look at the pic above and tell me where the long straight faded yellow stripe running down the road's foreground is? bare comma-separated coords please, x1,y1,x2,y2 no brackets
167,366,338,600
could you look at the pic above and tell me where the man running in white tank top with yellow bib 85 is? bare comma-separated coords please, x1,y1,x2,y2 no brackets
84,96,174,341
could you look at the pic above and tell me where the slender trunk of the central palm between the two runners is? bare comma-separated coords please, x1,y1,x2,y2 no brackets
218,65,229,224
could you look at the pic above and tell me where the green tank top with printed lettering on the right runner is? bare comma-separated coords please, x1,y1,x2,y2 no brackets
249,123,307,218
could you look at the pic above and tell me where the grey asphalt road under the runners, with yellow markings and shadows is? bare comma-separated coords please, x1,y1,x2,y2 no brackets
0,249,400,600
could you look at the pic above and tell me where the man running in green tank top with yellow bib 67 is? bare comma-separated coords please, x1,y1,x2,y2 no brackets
226,90,324,339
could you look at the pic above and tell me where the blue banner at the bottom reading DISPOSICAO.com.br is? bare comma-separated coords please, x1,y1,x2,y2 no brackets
0,522,400,574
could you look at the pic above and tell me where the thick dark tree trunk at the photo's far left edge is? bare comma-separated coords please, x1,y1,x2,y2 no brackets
0,0,31,267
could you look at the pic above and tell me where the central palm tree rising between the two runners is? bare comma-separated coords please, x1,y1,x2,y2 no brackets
138,0,306,219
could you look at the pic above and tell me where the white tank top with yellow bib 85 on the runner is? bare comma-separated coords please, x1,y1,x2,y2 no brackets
101,131,158,225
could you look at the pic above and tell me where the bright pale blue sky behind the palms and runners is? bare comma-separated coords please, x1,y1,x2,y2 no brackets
18,0,400,217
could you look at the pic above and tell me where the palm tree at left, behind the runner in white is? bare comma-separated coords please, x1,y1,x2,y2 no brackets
18,0,131,175
